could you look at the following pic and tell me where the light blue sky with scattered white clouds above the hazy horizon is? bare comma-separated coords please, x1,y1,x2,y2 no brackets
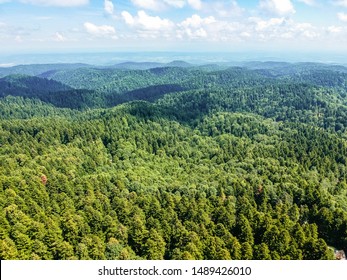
0,0,347,54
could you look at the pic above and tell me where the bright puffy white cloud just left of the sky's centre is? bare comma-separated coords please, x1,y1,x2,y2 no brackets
122,11,174,31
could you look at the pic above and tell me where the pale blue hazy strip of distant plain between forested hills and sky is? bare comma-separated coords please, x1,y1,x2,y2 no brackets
0,52,347,67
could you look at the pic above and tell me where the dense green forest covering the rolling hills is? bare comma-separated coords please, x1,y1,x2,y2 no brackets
0,61,347,260
